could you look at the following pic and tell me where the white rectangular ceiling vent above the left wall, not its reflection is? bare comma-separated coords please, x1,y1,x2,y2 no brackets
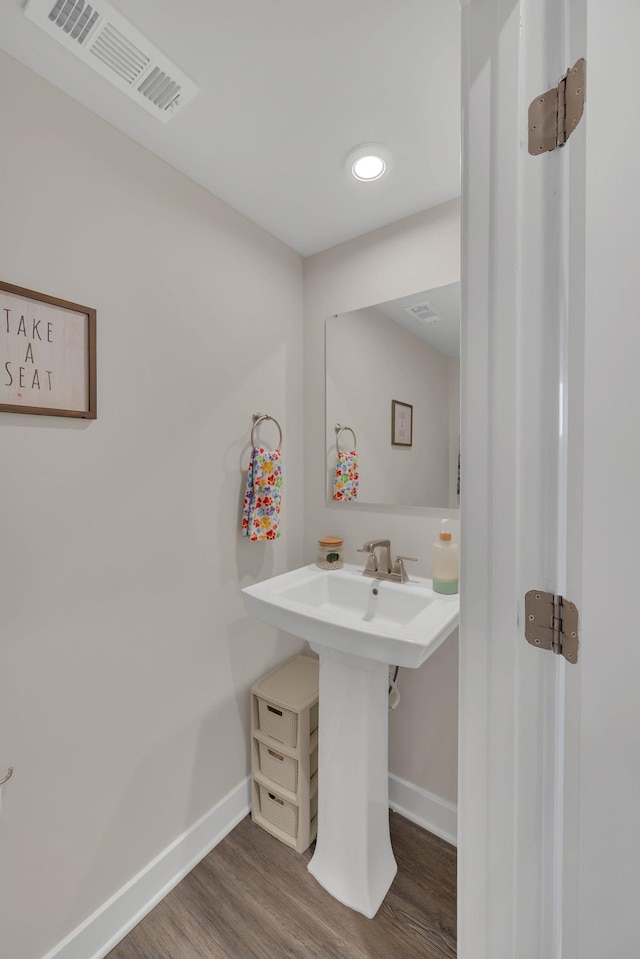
24,0,200,123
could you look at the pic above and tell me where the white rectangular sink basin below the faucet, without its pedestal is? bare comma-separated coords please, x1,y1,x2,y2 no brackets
242,565,459,668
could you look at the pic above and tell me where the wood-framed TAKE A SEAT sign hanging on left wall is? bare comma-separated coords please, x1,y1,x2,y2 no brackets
0,282,96,420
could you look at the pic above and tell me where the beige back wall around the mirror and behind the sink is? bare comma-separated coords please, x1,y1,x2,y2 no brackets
304,199,460,802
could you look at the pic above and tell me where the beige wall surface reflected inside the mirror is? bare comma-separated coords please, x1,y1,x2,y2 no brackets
326,308,452,506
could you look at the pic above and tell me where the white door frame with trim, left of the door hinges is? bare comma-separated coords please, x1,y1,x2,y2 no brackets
458,0,579,959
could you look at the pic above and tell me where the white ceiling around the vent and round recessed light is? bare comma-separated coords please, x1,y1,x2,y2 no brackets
0,0,460,256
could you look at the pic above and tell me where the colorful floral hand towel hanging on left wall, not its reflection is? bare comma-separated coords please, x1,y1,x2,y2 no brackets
242,446,282,543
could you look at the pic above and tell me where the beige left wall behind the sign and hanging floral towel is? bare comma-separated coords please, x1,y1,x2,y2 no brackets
0,55,303,959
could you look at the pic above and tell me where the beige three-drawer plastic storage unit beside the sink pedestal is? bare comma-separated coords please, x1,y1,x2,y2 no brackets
251,656,318,852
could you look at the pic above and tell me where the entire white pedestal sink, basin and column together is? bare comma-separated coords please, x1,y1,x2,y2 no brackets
242,566,459,918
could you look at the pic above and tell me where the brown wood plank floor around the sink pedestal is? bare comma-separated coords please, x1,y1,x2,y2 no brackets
107,813,456,959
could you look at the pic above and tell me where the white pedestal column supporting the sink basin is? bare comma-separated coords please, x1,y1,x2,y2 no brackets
309,642,398,919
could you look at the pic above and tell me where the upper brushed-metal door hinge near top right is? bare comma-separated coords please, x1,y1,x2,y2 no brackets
529,57,587,156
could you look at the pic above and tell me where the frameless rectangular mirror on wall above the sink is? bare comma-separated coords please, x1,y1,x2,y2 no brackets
325,282,460,509
